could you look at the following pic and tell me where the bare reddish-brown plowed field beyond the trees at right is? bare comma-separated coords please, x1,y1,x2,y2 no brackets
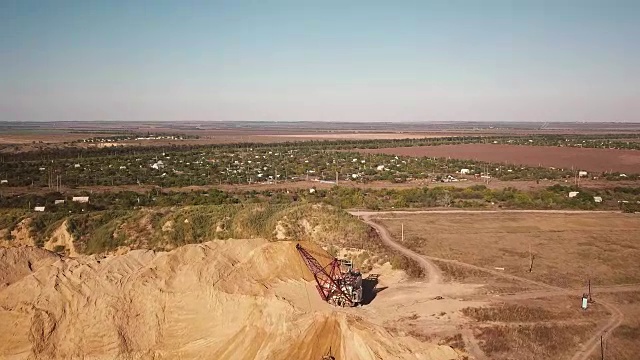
361,144,640,173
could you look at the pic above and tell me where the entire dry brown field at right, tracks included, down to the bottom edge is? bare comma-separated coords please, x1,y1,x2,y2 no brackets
375,212,640,360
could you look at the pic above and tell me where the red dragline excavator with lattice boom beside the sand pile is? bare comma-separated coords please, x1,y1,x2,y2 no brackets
296,244,362,307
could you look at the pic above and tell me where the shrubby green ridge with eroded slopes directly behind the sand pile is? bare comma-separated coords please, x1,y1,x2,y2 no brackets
0,204,370,254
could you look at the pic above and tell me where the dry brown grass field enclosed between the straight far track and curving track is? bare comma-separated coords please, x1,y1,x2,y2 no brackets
376,212,640,288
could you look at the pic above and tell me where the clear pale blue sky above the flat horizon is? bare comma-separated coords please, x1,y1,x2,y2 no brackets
0,0,640,122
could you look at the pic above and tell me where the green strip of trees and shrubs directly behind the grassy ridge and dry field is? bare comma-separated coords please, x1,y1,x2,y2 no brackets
0,185,640,215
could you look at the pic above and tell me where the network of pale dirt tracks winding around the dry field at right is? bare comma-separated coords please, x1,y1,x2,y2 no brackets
350,210,640,360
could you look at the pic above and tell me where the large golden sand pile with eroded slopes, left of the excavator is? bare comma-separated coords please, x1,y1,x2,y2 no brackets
0,239,457,360
